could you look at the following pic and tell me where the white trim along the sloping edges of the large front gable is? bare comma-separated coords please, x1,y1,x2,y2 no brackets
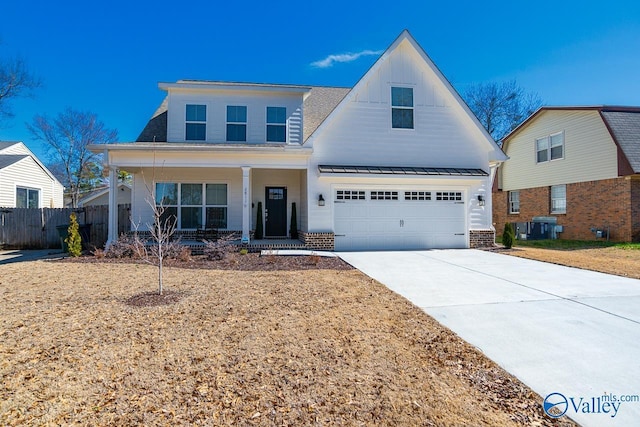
309,30,508,162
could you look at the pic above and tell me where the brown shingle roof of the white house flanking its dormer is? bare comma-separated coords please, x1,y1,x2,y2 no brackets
136,83,351,142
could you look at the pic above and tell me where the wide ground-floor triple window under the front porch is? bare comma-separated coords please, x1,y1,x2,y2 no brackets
155,182,228,230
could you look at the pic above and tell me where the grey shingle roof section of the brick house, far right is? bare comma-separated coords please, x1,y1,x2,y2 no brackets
601,109,640,173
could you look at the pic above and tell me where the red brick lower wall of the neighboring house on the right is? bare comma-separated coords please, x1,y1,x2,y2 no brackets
493,177,640,242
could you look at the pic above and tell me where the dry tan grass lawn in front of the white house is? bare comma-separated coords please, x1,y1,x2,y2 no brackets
0,261,572,426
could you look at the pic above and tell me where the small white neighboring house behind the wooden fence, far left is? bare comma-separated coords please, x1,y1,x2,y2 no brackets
0,142,64,208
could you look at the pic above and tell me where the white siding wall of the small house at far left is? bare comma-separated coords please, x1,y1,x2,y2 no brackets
0,159,63,208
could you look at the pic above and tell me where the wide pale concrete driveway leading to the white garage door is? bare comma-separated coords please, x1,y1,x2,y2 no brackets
339,249,640,426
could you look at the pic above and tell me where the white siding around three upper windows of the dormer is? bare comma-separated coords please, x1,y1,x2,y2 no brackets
167,89,303,144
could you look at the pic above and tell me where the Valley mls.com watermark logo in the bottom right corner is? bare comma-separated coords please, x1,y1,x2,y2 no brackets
542,392,640,418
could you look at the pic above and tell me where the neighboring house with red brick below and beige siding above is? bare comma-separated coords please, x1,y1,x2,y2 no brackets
493,106,640,241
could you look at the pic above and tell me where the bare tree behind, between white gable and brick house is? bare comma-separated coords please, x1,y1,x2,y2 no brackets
464,80,542,143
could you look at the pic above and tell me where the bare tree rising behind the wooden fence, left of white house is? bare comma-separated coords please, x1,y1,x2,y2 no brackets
27,108,118,208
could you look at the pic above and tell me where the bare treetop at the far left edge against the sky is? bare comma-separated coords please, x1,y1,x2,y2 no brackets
0,57,42,120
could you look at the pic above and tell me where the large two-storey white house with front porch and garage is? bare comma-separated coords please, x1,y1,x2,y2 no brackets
92,31,507,251
